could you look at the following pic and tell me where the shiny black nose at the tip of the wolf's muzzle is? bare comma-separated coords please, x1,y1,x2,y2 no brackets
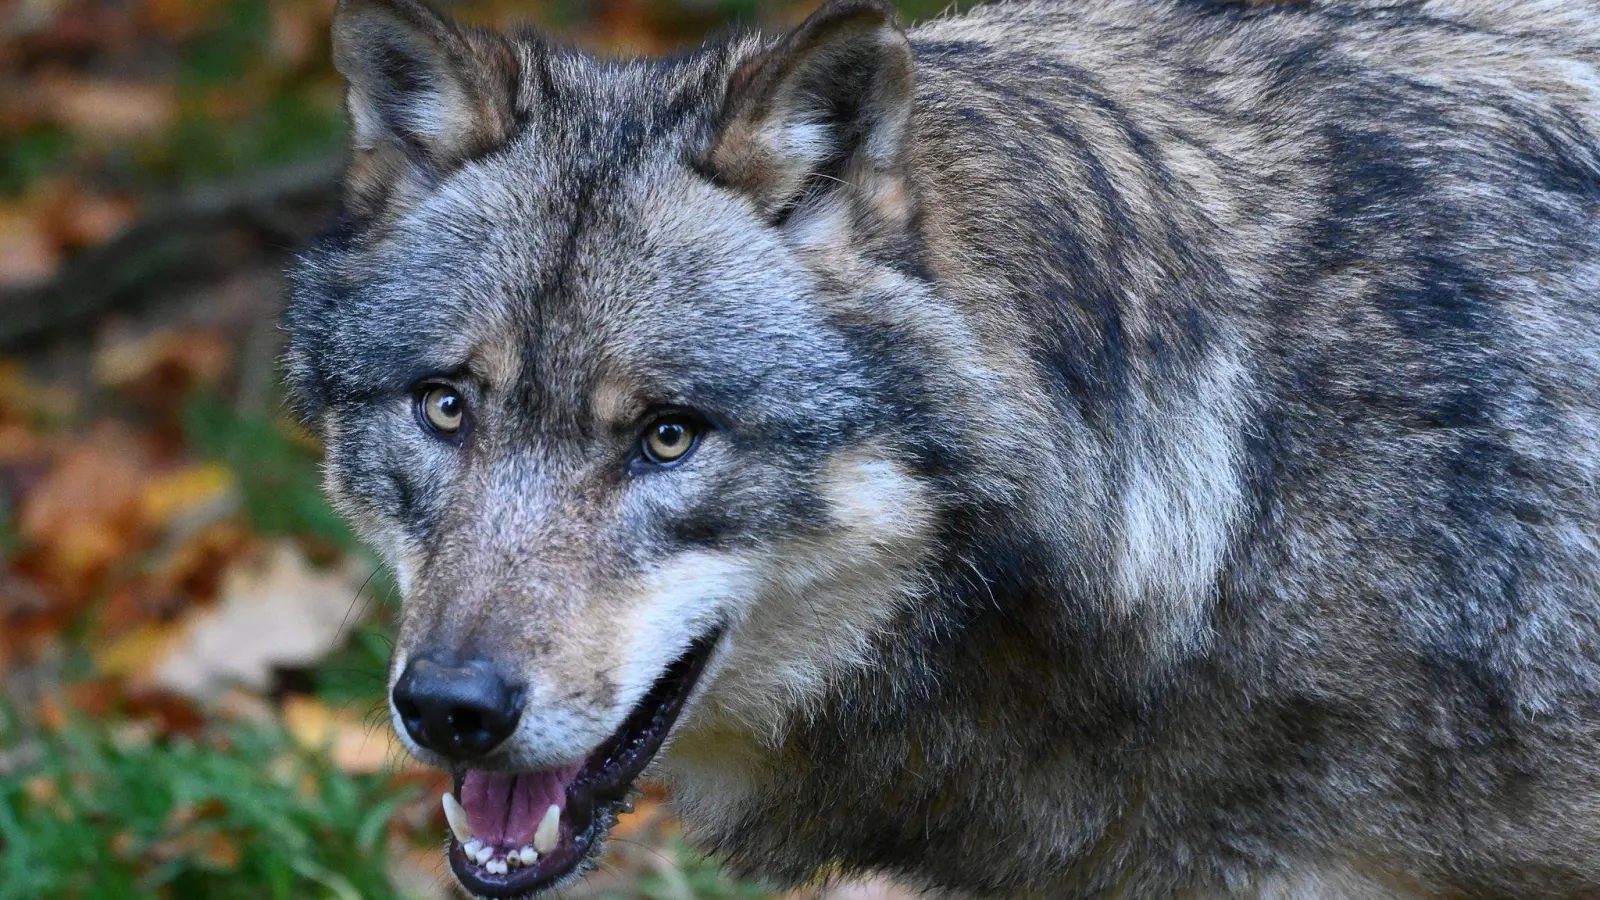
394,652,522,759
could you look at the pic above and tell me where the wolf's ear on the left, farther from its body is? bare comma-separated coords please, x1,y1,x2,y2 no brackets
333,0,518,215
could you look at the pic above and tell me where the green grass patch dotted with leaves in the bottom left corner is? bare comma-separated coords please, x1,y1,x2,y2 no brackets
0,707,408,900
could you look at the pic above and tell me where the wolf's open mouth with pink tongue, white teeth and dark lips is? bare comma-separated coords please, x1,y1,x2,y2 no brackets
432,631,720,898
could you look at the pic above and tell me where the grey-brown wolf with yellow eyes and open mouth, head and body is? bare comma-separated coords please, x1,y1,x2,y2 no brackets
285,0,1600,900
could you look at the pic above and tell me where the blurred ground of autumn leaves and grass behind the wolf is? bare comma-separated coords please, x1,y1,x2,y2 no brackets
0,0,946,900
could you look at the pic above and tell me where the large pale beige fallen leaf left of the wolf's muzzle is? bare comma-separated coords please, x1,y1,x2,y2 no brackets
152,541,366,700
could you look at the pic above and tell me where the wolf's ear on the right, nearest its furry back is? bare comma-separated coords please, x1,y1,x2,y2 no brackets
707,0,914,224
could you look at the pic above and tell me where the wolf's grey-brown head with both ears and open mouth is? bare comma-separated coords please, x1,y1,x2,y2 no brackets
288,0,981,895
